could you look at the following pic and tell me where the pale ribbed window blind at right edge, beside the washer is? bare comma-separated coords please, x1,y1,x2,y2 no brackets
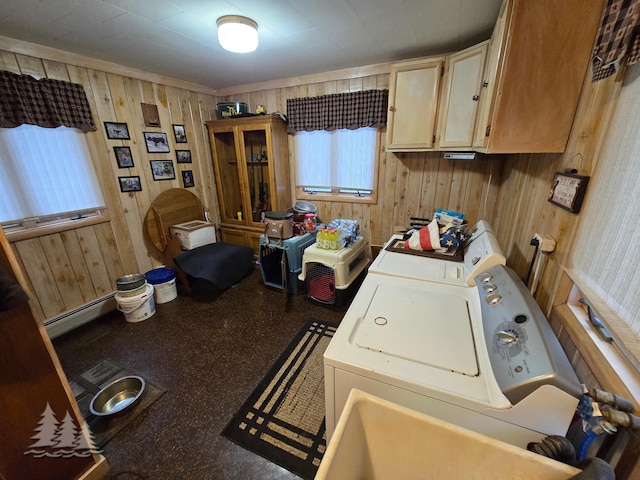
570,64,640,366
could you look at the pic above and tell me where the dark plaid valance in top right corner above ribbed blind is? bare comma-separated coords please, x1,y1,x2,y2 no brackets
593,0,640,82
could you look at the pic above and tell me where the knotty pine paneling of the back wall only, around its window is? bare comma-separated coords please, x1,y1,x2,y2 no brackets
219,82,504,245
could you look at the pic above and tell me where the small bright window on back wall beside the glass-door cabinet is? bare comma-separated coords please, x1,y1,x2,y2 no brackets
293,127,379,202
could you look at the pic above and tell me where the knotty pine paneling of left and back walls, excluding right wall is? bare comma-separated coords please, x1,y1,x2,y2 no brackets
0,43,503,319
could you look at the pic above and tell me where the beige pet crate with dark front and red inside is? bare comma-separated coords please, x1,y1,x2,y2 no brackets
299,237,371,307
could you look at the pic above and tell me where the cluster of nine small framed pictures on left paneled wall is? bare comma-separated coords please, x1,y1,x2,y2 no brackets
104,103,195,193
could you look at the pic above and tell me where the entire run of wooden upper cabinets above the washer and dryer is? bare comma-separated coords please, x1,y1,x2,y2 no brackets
387,0,603,153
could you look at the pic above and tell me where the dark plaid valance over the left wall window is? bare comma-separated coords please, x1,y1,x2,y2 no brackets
0,71,96,132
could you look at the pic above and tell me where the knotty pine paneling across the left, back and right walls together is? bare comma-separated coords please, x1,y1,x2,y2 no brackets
0,37,617,319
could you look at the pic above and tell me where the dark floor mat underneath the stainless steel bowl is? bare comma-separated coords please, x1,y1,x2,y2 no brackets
69,359,167,449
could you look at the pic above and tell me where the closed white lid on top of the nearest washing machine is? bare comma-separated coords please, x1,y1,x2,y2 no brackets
353,284,479,376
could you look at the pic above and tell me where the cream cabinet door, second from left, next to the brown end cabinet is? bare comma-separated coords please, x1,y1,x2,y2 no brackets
438,41,489,149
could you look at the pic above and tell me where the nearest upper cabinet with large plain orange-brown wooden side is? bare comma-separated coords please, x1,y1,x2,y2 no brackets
474,0,604,153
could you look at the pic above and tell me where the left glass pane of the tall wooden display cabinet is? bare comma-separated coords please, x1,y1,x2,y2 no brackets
211,130,245,223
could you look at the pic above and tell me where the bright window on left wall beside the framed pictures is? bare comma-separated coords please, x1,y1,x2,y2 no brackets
0,125,104,225
